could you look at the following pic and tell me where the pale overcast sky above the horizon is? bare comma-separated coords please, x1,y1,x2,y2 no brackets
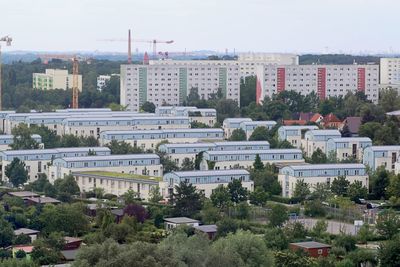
0,0,400,54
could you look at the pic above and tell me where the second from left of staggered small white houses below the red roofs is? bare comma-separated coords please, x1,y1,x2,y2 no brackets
301,130,342,157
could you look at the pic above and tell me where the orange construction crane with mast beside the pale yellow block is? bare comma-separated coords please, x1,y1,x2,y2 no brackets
38,54,89,108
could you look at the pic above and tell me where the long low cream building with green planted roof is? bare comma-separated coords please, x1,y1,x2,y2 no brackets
72,172,161,200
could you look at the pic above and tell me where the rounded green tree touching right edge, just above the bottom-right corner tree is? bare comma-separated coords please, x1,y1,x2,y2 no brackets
375,209,400,239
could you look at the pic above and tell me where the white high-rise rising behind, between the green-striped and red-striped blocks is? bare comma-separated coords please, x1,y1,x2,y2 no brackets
238,53,299,77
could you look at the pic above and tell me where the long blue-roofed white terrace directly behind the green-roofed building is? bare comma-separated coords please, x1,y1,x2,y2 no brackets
49,154,162,182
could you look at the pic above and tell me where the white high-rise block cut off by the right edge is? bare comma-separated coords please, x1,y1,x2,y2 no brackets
380,58,400,88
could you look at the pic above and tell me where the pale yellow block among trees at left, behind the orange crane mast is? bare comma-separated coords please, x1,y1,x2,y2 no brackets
32,69,82,91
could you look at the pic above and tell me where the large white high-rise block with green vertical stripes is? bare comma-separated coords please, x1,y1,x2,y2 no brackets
120,60,240,111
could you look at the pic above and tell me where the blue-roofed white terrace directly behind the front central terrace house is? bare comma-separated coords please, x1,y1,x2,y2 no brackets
202,149,304,170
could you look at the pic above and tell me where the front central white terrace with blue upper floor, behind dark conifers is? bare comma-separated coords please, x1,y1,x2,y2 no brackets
162,170,254,198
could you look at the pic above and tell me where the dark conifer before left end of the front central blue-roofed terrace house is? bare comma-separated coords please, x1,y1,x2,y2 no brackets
173,182,203,217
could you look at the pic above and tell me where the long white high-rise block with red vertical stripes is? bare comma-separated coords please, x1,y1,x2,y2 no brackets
256,64,379,103
